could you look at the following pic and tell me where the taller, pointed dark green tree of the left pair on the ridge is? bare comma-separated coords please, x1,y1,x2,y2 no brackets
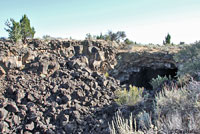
20,15,35,43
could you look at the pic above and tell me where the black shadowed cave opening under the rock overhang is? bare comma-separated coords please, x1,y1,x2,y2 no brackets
121,67,178,89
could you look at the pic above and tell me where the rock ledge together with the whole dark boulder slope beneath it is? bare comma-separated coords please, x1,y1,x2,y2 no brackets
0,40,120,134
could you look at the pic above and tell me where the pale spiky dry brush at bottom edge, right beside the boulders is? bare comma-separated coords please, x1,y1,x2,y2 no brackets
109,111,157,134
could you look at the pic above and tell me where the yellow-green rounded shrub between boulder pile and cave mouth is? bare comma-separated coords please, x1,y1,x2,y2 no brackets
115,85,144,106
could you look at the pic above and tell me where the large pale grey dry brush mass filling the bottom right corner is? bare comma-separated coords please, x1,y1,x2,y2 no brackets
156,81,200,133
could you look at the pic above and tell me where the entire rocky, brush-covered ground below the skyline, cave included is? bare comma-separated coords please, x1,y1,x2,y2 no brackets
0,39,200,134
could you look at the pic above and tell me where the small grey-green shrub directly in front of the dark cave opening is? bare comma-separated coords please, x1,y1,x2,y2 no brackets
150,75,171,89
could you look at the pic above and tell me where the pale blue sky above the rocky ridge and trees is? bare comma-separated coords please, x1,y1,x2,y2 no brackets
0,0,200,44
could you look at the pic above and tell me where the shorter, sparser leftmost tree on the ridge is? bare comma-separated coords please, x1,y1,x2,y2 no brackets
5,19,22,43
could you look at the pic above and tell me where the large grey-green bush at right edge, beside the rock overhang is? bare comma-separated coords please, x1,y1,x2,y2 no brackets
174,42,200,80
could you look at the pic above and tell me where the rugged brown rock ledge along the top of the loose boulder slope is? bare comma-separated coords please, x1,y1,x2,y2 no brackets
0,40,117,76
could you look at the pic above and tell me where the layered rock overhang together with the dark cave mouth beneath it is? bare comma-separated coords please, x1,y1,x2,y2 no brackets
110,46,177,88
